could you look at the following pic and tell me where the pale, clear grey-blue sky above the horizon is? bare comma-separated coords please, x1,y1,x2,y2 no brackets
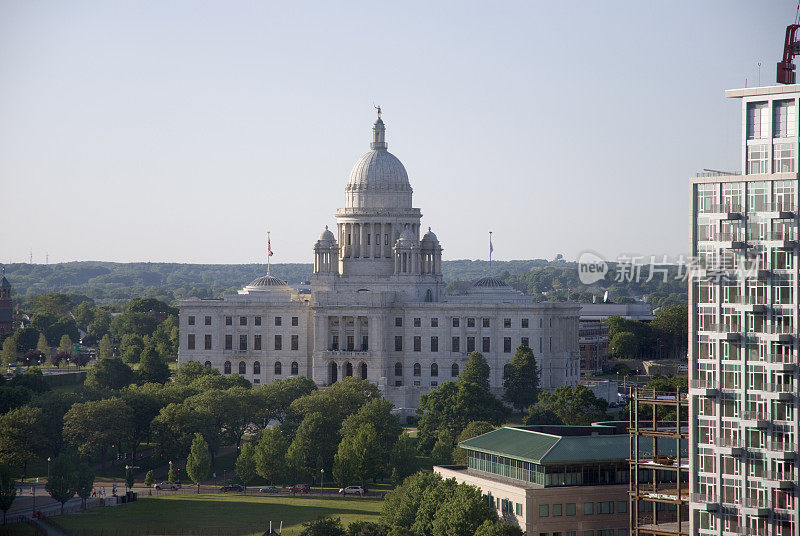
0,0,797,264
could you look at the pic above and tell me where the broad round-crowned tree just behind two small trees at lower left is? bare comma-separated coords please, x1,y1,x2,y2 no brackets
64,398,134,460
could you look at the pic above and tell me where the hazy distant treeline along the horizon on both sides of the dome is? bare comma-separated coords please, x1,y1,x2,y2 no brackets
6,259,687,307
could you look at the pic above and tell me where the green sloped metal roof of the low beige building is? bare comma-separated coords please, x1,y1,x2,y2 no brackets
458,426,629,465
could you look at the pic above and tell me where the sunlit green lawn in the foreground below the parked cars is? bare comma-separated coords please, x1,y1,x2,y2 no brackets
50,494,382,536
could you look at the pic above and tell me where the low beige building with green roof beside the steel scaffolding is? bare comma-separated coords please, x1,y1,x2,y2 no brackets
434,423,629,536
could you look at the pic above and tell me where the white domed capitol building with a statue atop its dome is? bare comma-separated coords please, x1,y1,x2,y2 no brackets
178,110,580,410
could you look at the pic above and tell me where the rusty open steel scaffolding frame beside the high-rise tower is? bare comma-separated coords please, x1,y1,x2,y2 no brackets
628,388,689,536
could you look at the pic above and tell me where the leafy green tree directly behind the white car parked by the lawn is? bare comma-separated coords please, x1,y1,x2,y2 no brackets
333,423,381,487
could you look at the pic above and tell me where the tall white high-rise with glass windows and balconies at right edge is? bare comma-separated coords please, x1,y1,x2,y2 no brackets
689,84,800,536
